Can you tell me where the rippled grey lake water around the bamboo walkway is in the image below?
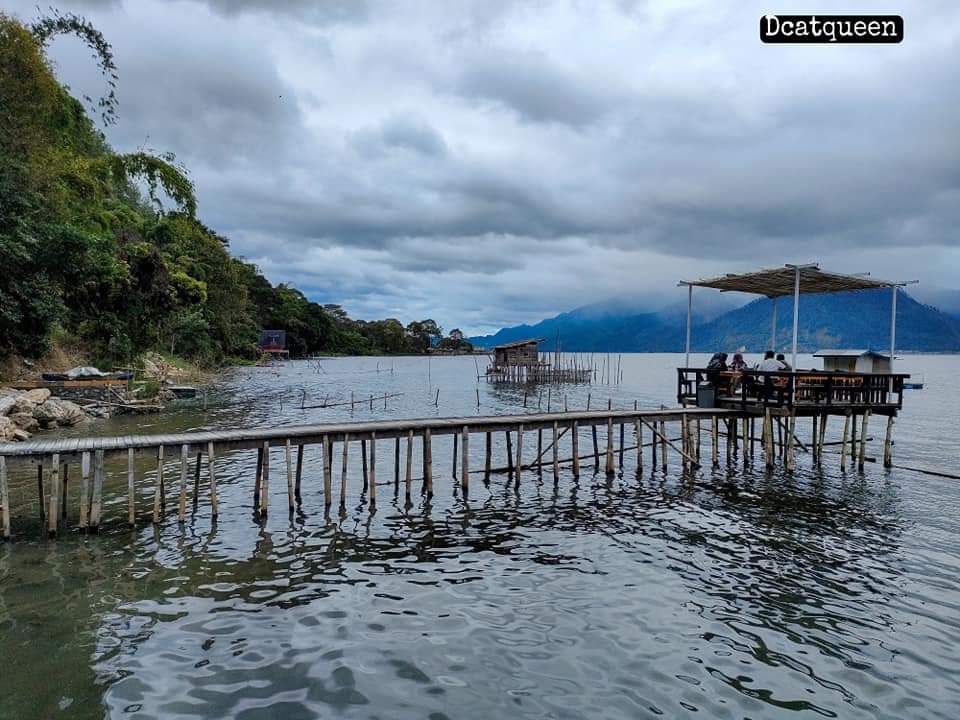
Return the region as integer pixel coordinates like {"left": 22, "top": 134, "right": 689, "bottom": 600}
{"left": 0, "top": 355, "right": 960, "bottom": 720}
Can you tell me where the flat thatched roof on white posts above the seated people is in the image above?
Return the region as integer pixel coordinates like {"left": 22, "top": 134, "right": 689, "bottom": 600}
{"left": 680, "top": 264, "right": 900, "bottom": 298}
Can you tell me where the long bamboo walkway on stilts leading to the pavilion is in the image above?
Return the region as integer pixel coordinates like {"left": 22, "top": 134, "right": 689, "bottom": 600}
{"left": 0, "top": 407, "right": 896, "bottom": 539}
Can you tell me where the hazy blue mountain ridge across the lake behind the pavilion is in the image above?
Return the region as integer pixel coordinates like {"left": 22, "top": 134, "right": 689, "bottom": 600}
{"left": 470, "top": 290, "right": 960, "bottom": 352}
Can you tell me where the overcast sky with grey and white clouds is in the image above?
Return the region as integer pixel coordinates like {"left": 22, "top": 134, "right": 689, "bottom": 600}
{"left": 9, "top": 0, "right": 960, "bottom": 332}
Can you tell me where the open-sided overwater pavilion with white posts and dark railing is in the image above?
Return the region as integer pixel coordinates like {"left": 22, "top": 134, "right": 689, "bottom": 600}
{"left": 677, "top": 263, "right": 914, "bottom": 417}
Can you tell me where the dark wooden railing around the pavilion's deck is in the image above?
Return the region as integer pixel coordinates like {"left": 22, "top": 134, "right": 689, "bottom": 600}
{"left": 677, "top": 368, "right": 910, "bottom": 410}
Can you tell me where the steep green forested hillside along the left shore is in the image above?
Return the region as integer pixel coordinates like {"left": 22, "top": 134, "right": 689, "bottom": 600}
{"left": 0, "top": 13, "right": 440, "bottom": 365}
